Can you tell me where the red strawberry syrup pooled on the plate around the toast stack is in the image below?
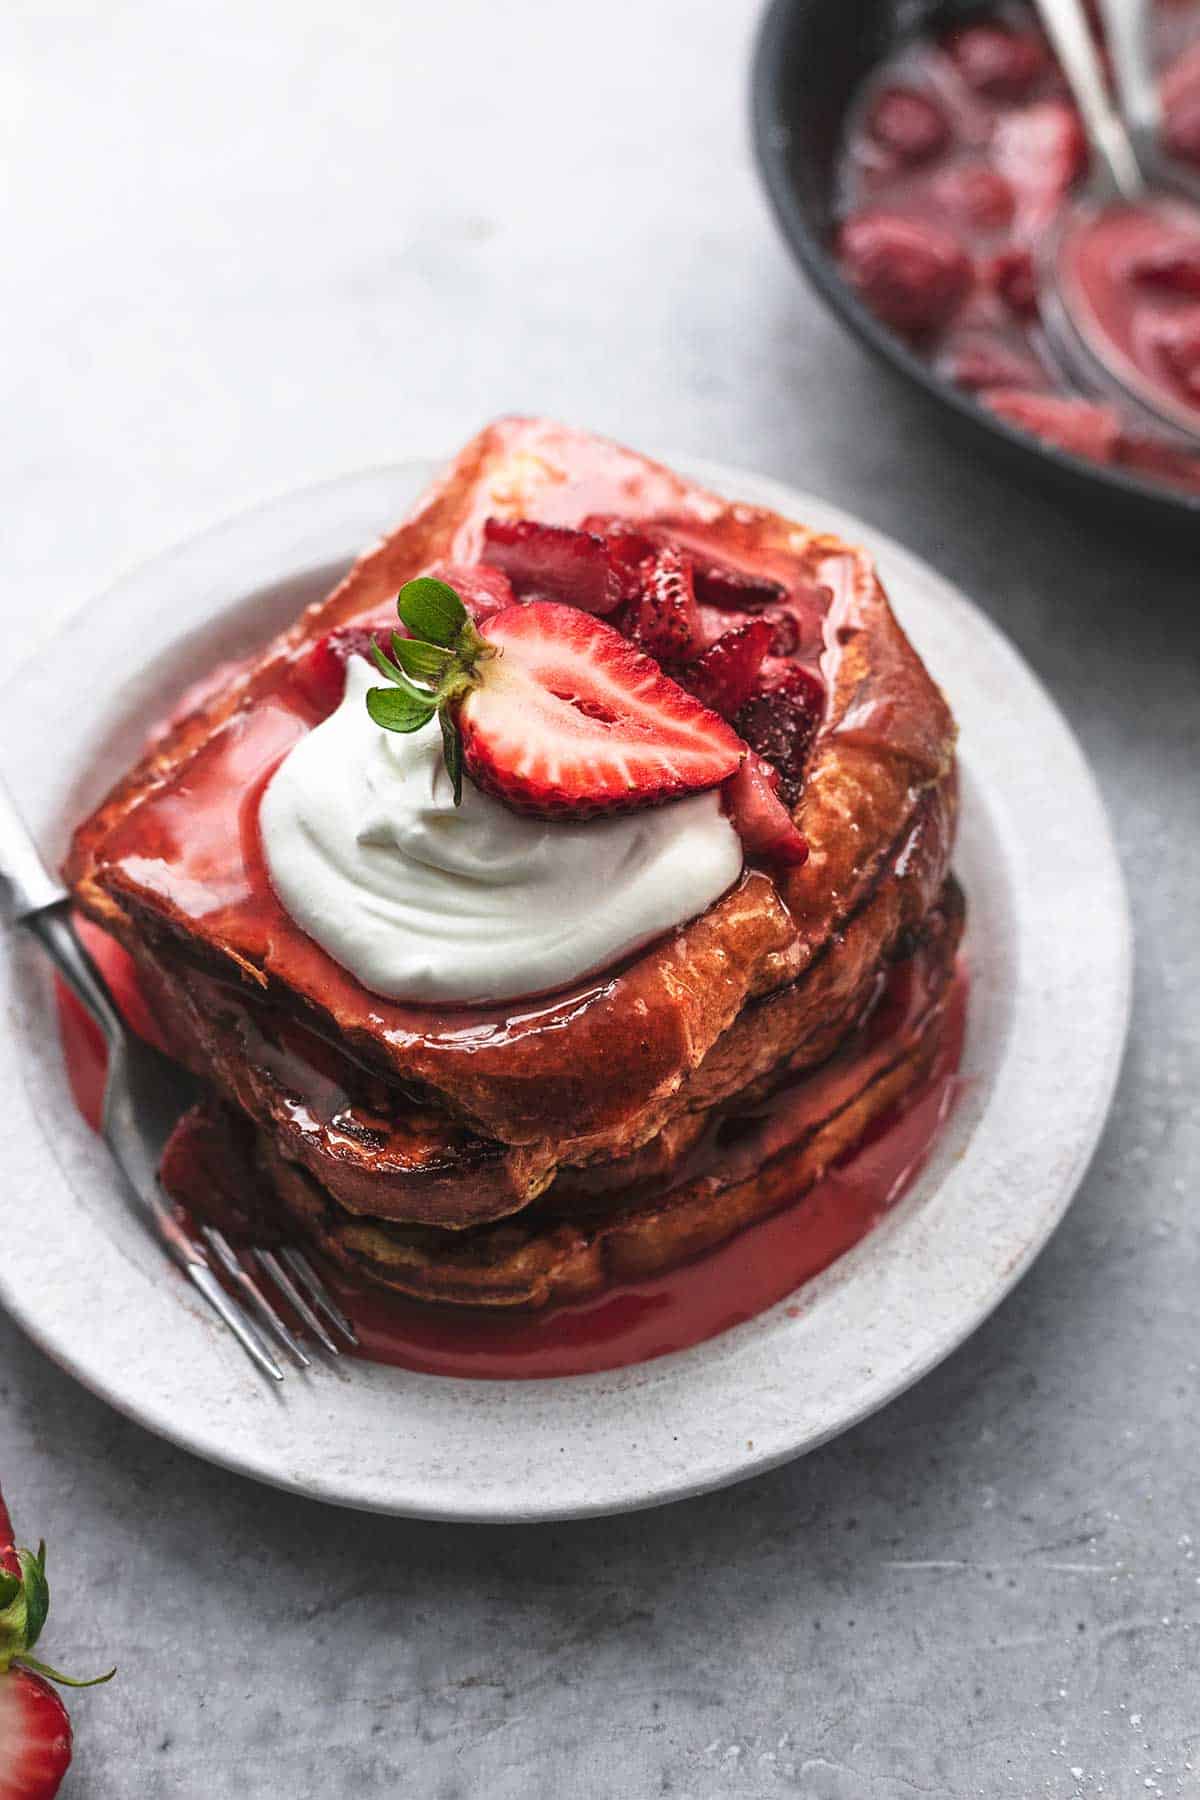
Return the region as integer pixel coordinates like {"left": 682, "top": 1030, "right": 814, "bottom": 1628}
{"left": 58, "top": 920, "right": 966, "bottom": 1381}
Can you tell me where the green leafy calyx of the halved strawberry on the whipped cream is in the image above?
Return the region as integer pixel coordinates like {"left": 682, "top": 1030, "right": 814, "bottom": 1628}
{"left": 367, "top": 574, "right": 497, "bottom": 806}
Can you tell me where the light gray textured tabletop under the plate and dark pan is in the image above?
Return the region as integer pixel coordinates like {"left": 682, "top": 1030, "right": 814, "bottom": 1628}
{"left": 0, "top": 0, "right": 1200, "bottom": 1800}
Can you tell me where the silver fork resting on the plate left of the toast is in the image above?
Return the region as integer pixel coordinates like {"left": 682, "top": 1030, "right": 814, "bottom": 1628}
{"left": 0, "top": 781, "right": 358, "bottom": 1381}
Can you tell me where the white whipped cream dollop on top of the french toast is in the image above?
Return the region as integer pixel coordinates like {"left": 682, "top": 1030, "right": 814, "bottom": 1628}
{"left": 259, "top": 657, "right": 741, "bottom": 1004}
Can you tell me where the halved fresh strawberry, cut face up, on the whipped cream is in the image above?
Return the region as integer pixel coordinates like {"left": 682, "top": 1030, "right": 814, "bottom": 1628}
{"left": 457, "top": 601, "right": 745, "bottom": 819}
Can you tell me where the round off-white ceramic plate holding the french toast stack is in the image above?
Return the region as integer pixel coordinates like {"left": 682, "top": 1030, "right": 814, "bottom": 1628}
{"left": 0, "top": 463, "right": 1130, "bottom": 1519}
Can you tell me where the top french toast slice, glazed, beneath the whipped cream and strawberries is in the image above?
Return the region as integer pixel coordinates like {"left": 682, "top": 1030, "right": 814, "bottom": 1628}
{"left": 67, "top": 419, "right": 955, "bottom": 1159}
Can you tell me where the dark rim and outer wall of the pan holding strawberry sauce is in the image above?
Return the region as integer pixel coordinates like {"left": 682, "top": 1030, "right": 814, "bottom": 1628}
{"left": 752, "top": 0, "right": 1200, "bottom": 531}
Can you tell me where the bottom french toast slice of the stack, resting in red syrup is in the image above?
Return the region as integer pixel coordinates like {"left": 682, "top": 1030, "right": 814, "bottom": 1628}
{"left": 164, "top": 882, "right": 963, "bottom": 1309}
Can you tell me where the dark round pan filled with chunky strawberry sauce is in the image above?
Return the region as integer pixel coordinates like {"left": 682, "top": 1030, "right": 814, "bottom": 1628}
{"left": 754, "top": 0, "right": 1200, "bottom": 527}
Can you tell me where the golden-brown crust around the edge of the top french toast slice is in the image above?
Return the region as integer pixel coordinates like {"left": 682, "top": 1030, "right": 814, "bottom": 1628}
{"left": 67, "top": 419, "right": 954, "bottom": 1159}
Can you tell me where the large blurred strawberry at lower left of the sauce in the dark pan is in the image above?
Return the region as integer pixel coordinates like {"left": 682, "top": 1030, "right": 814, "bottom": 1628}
{"left": 838, "top": 212, "right": 972, "bottom": 337}
